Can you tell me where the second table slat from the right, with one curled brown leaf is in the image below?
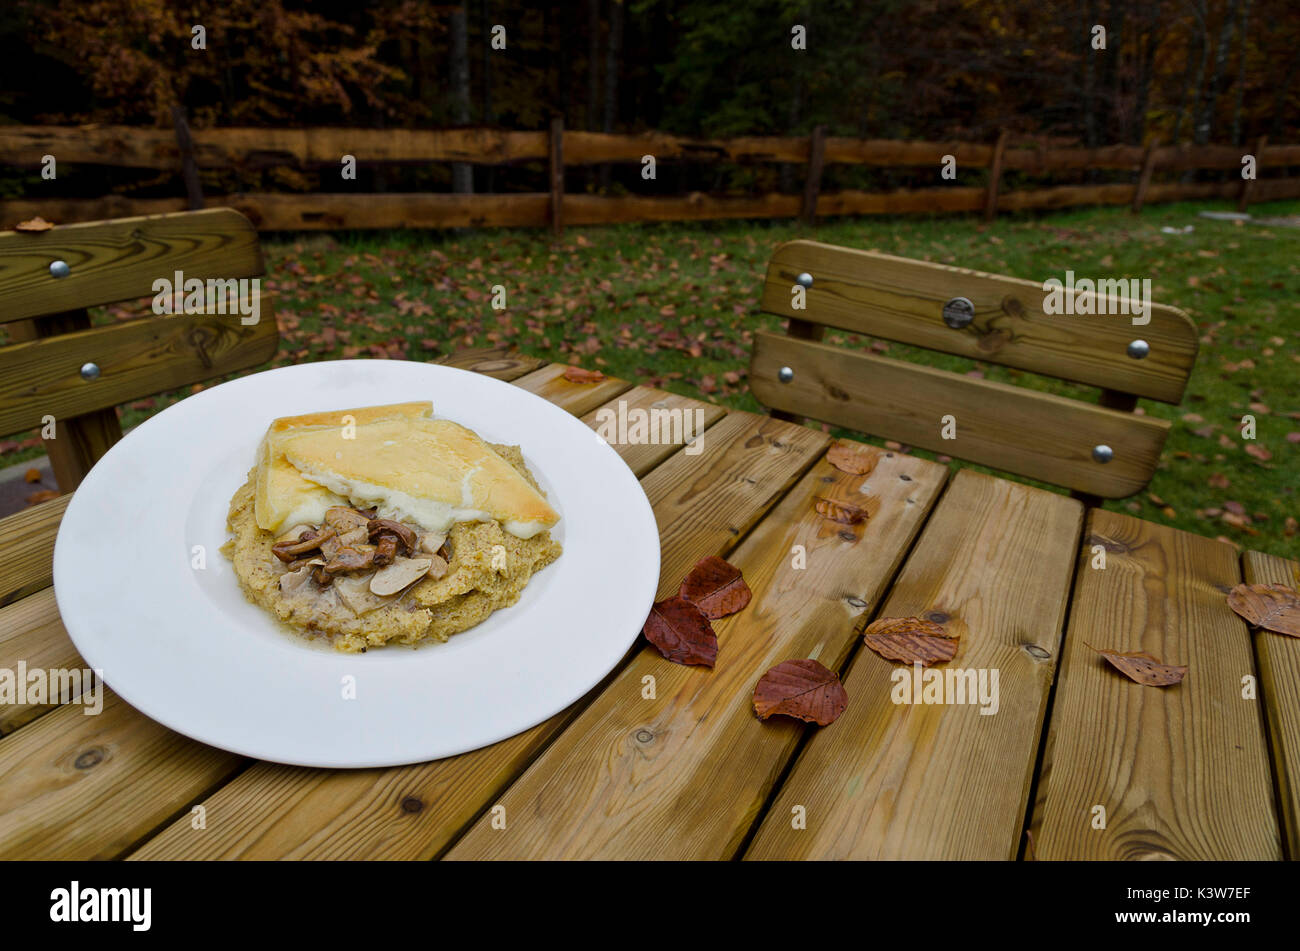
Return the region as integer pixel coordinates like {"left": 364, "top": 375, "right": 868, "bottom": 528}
{"left": 1032, "top": 509, "right": 1282, "bottom": 860}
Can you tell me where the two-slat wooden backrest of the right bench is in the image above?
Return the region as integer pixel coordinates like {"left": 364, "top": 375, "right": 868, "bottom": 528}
{"left": 750, "top": 240, "right": 1197, "bottom": 499}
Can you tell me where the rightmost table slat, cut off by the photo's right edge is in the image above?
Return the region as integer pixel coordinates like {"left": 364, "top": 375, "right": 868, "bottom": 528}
{"left": 1242, "top": 551, "right": 1300, "bottom": 859}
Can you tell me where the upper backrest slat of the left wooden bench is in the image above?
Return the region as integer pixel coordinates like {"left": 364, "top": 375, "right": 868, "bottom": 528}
{"left": 0, "top": 208, "right": 263, "bottom": 323}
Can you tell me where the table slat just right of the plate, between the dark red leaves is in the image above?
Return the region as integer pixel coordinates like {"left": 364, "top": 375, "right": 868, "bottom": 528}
{"left": 447, "top": 447, "right": 948, "bottom": 859}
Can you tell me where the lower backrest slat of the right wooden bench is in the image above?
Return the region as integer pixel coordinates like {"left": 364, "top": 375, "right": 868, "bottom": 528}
{"left": 750, "top": 333, "right": 1170, "bottom": 499}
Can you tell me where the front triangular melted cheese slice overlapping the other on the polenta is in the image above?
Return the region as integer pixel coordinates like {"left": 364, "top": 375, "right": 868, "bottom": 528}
{"left": 277, "top": 417, "right": 559, "bottom": 538}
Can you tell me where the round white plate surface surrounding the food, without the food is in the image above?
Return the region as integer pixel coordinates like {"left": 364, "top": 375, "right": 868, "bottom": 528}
{"left": 55, "top": 360, "right": 659, "bottom": 767}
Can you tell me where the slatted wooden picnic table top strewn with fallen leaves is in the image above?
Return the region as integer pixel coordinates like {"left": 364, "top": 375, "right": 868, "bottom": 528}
{"left": 0, "top": 342, "right": 1300, "bottom": 859}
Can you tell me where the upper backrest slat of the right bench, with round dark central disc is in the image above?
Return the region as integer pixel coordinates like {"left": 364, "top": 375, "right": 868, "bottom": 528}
{"left": 762, "top": 240, "right": 1199, "bottom": 403}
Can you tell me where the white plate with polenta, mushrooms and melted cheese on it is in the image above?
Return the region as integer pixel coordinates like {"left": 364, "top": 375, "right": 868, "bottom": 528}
{"left": 55, "top": 360, "right": 659, "bottom": 767}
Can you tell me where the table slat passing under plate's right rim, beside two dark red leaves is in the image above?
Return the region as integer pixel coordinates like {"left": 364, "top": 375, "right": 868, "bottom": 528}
{"left": 131, "top": 400, "right": 827, "bottom": 859}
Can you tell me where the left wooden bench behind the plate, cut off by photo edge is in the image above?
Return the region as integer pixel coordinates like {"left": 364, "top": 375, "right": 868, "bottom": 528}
{"left": 0, "top": 208, "right": 280, "bottom": 492}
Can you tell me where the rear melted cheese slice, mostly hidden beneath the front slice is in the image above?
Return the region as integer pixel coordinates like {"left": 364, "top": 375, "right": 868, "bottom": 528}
{"left": 254, "top": 400, "right": 433, "bottom": 531}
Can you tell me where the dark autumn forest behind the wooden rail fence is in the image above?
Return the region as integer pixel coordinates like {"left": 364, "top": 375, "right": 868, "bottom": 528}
{"left": 0, "top": 0, "right": 1300, "bottom": 195}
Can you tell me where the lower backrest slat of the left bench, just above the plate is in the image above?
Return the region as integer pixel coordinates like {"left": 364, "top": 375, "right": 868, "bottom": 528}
{"left": 0, "top": 313, "right": 280, "bottom": 434}
